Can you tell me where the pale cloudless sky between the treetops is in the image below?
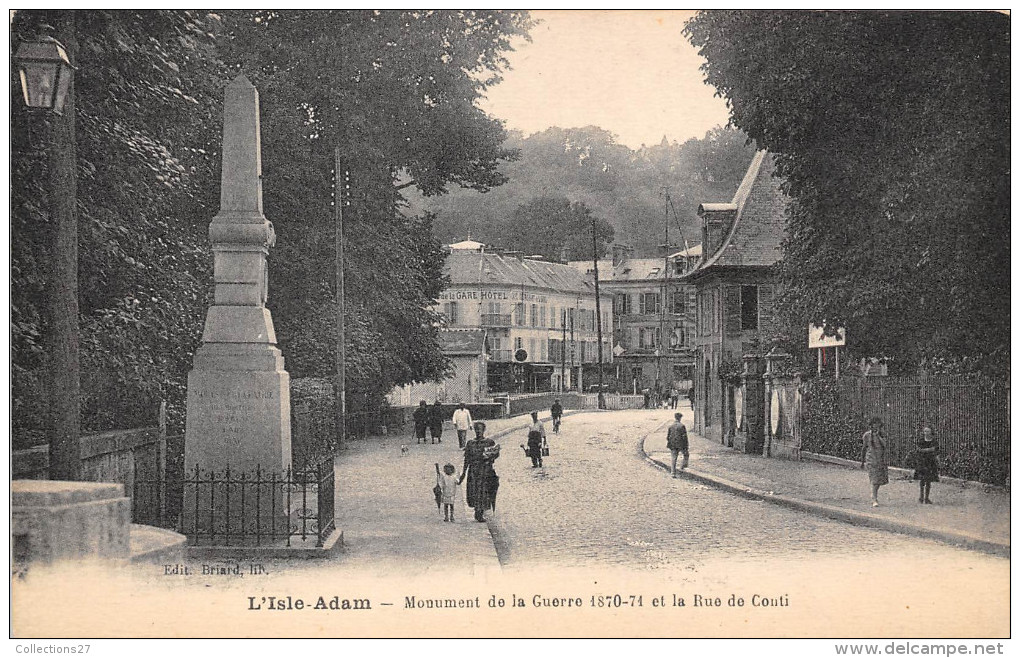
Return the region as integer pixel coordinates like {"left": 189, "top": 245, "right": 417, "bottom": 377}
{"left": 480, "top": 10, "right": 729, "bottom": 148}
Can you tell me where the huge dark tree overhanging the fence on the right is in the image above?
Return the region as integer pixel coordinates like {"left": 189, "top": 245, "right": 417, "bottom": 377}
{"left": 685, "top": 11, "right": 1010, "bottom": 369}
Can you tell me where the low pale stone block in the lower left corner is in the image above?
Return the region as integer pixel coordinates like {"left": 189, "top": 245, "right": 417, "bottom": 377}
{"left": 11, "top": 479, "right": 131, "bottom": 566}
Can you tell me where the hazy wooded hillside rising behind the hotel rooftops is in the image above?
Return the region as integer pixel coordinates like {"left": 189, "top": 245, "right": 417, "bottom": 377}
{"left": 422, "top": 125, "right": 754, "bottom": 256}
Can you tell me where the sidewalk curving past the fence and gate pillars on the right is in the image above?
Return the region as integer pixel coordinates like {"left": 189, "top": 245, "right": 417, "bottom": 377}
{"left": 643, "top": 408, "right": 1010, "bottom": 556}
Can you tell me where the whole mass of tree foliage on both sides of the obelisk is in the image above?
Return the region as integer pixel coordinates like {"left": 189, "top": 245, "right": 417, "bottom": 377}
{"left": 9, "top": 10, "right": 530, "bottom": 435}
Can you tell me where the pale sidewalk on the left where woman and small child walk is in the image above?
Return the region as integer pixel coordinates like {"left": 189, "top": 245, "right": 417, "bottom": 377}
{"left": 336, "top": 412, "right": 569, "bottom": 577}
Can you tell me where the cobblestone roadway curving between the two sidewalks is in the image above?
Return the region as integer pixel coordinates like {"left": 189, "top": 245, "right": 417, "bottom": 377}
{"left": 489, "top": 410, "right": 939, "bottom": 568}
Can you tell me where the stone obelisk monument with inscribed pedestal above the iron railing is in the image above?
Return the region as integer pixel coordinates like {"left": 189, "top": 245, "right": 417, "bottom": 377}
{"left": 185, "top": 75, "right": 291, "bottom": 473}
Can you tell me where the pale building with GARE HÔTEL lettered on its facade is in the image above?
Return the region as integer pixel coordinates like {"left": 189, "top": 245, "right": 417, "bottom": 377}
{"left": 438, "top": 242, "right": 613, "bottom": 396}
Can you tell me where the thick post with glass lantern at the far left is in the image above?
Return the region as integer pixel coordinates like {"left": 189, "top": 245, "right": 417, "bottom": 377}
{"left": 14, "top": 21, "right": 82, "bottom": 480}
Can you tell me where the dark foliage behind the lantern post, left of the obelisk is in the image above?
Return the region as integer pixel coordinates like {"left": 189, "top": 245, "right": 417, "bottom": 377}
{"left": 10, "top": 11, "right": 221, "bottom": 445}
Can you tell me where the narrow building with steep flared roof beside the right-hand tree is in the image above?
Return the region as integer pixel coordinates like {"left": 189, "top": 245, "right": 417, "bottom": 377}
{"left": 683, "top": 151, "right": 786, "bottom": 442}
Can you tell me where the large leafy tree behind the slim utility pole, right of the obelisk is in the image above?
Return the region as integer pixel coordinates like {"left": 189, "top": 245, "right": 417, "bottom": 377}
{"left": 221, "top": 10, "right": 530, "bottom": 411}
